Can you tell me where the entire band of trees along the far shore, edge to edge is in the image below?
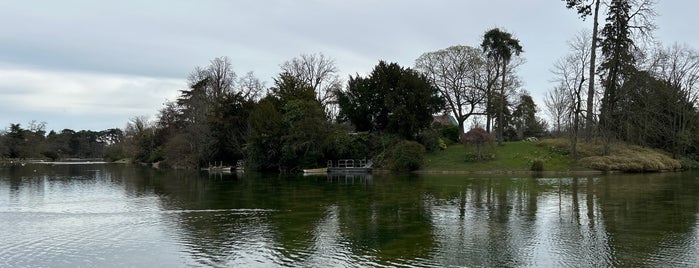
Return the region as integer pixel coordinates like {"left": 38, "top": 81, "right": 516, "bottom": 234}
{"left": 0, "top": 0, "right": 699, "bottom": 172}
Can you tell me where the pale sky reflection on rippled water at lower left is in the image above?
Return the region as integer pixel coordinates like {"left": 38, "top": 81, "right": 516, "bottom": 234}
{"left": 0, "top": 164, "right": 187, "bottom": 267}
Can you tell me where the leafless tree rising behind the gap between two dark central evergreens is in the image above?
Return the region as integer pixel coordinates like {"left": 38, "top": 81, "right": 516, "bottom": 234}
{"left": 281, "top": 53, "right": 342, "bottom": 117}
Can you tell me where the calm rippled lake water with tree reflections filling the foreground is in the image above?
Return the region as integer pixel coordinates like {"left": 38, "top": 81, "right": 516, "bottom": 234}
{"left": 0, "top": 164, "right": 699, "bottom": 267}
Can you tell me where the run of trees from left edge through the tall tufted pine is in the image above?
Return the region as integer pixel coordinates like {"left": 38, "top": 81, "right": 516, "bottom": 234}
{"left": 0, "top": 29, "right": 545, "bottom": 171}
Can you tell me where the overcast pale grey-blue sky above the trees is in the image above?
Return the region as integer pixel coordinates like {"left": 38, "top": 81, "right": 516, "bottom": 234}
{"left": 0, "top": 0, "right": 699, "bottom": 130}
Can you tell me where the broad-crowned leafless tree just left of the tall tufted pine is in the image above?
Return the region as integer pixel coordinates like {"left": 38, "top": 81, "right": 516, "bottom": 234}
{"left": 415, "top": 46, "right": 486, "bottom": 135}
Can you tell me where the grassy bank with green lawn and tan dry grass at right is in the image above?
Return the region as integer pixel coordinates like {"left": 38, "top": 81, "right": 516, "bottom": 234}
{"left": 422, "top": 139, "right": 681, "bottom": 173}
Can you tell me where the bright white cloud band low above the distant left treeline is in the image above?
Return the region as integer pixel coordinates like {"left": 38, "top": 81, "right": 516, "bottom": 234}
{"left": 0, "top": 67, "right": 186, "bottom": 130}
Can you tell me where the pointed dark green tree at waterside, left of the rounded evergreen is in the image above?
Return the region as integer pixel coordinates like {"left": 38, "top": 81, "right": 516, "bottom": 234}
{"left": 246, "top": 73, "right": 334, "bottom": 171}
